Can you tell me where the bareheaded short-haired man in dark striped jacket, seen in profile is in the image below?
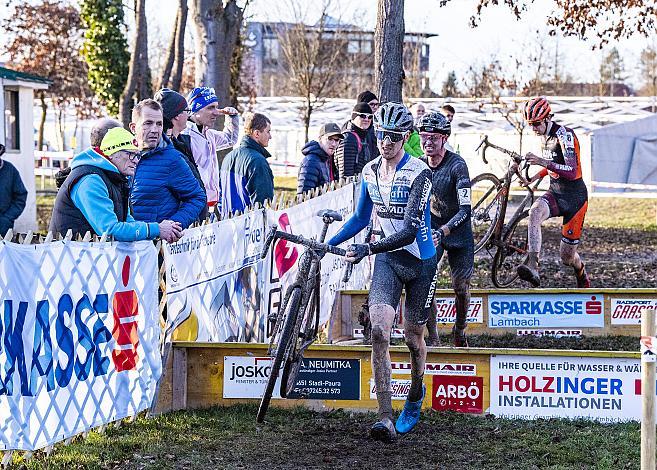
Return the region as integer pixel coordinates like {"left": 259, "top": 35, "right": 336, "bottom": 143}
{"left": 221, "top": 113, "right": 274, "bottom": 217}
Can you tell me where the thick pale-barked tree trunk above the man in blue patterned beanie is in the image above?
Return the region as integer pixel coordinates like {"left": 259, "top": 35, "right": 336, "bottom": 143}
{"left": 192, "top": 0, "right": 244, "bottom": 106}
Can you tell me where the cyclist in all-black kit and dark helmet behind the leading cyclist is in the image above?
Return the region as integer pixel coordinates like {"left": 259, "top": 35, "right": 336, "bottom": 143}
{"left": 418, "top": 112, "right": 474, "bottom": 347}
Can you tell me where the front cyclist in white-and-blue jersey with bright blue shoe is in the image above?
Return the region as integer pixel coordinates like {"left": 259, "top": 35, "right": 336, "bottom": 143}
{"left": 328, "top": 103, "right": 436, "bottom": 442}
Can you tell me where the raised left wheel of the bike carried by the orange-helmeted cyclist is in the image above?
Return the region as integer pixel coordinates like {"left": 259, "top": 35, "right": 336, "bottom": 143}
{"left": 470, "top": 173, "right": 502, "bottom": 253}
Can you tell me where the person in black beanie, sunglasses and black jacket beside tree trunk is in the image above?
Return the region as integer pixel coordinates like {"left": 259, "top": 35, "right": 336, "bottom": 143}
{"left": 332, "top": 103, "right": 373, "bottom": 180}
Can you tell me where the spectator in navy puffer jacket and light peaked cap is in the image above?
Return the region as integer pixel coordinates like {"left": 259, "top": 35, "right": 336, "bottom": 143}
{"left": 297, "top": 122, "right": 344, "bottom": 194}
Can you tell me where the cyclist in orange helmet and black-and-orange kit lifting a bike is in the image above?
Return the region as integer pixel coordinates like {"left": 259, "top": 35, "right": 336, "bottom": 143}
{"left": 517, "top": 96, "right": 591, "bottom": 287}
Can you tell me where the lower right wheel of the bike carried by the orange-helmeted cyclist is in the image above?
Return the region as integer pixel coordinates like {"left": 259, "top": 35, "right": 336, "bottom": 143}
{"left": 492, "top": 211, "right": 529, "bottom": 287}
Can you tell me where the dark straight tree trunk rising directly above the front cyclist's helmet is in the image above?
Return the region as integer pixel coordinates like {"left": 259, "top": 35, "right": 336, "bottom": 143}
{"left": 374, "top": 0, "right": 404, "bottom": 103}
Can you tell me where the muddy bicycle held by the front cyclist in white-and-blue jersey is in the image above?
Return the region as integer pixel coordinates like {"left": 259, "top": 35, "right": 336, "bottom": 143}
{"left": 256, "top": 210, "right": 353, "bottom": 423}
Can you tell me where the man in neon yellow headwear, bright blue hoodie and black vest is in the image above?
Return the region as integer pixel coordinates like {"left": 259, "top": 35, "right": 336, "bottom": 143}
{"left": 49, "top": 127, "right": 182, "bottom": 242}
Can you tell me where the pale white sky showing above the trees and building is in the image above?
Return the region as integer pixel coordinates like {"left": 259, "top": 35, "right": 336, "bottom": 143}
{"left": 0, "top": 0, "right": 648, "bottom": 91}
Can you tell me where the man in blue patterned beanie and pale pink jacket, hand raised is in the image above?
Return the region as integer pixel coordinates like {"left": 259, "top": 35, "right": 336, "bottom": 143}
{"left": 182, "top": 87, "right": 239, "bottom": 207}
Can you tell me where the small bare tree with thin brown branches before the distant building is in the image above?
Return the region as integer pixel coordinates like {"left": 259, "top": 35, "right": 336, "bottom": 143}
{"left": 278, "top": 2, "right": 348, "bottom": 141}
